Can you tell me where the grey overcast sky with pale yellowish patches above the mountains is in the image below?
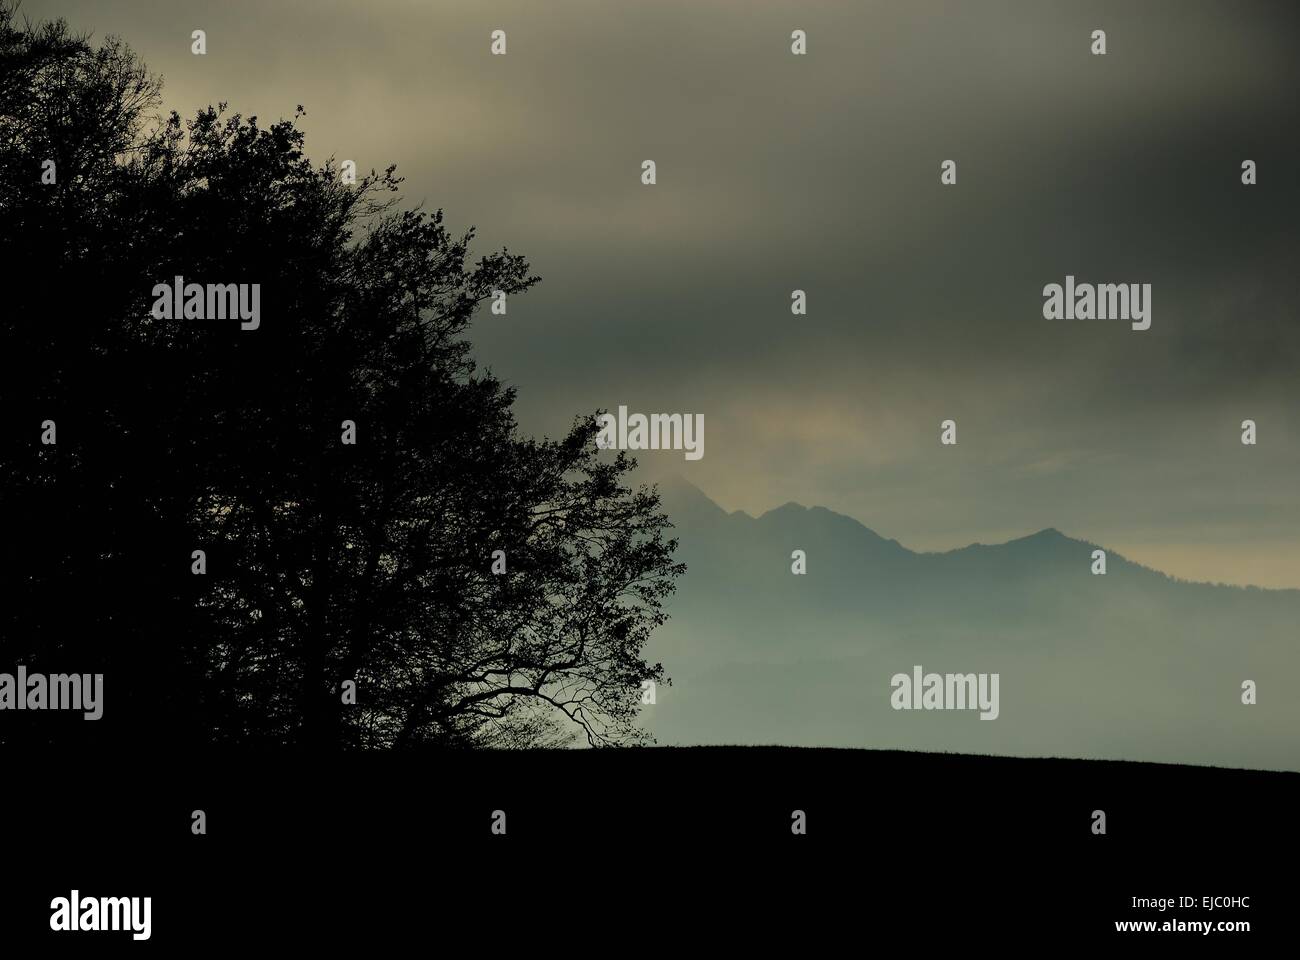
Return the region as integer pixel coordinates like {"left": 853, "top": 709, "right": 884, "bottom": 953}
{"left": 32, "top": 0, "right": 1300, "bottom": 587}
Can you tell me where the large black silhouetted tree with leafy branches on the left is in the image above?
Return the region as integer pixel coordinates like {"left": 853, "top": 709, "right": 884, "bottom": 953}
{"left": 0, "top": 9, "right": 683, "bottom": 749}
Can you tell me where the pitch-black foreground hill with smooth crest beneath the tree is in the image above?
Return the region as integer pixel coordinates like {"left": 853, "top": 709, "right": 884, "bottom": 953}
{"left": 0, "top": 747, "right": 1300, "bottom": 947}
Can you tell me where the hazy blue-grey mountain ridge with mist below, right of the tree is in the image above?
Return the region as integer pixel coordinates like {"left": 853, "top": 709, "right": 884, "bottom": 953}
{"left": 645, "top": 479, "right": 1300, "bottom": 770}
